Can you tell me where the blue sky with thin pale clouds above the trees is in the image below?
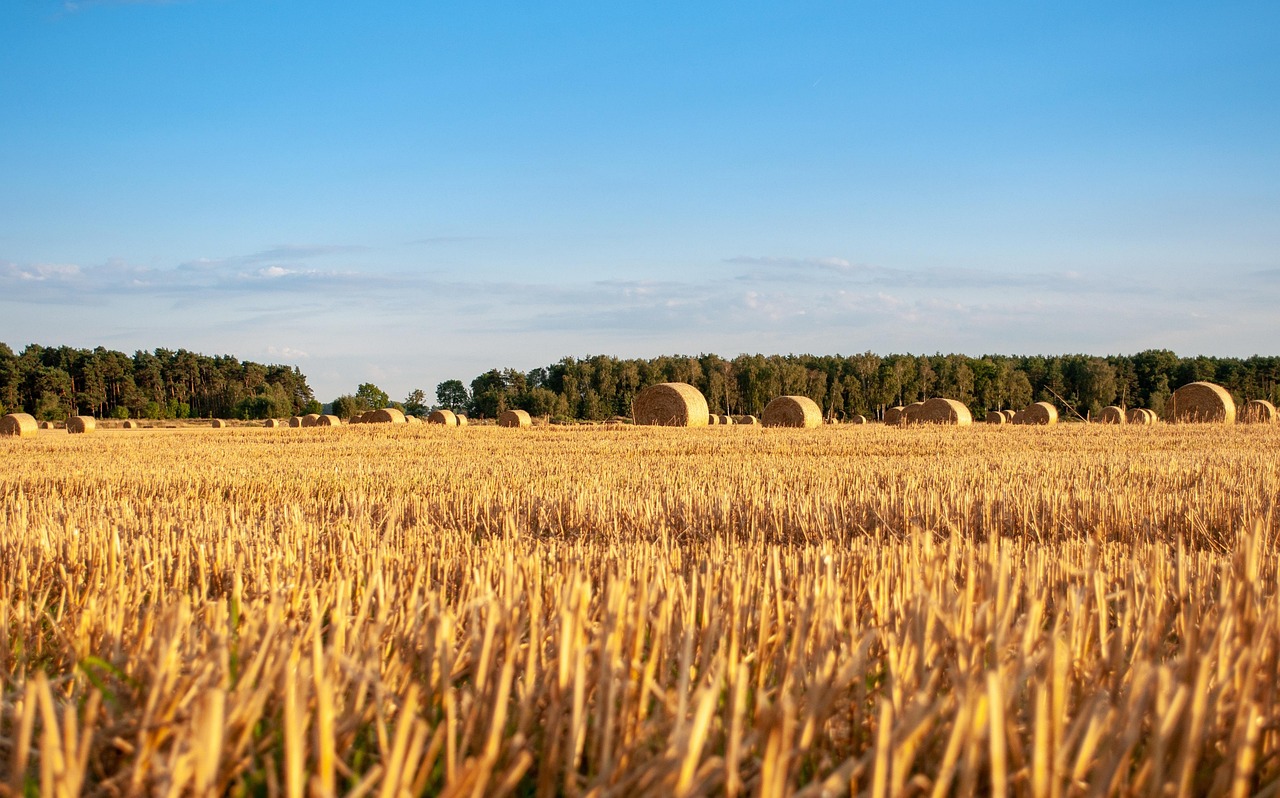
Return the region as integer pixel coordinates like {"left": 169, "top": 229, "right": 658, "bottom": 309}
{"left": 0, "top": 0, "right": 1280, "bottom": 400}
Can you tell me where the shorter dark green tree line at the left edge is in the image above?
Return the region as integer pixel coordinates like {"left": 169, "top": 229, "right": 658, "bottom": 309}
{"left": 0, "top": 343, "right": 320, "bottom": 420}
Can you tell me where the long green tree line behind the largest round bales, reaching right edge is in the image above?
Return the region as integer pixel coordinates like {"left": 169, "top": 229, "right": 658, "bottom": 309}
{"left": 436, "top": 350, "right": 1280, "bottom": 420}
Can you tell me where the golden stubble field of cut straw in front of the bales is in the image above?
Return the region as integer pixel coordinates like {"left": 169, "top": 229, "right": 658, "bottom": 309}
{"left": 0, "top": 425, "right": 1280, "bottom": 797}
